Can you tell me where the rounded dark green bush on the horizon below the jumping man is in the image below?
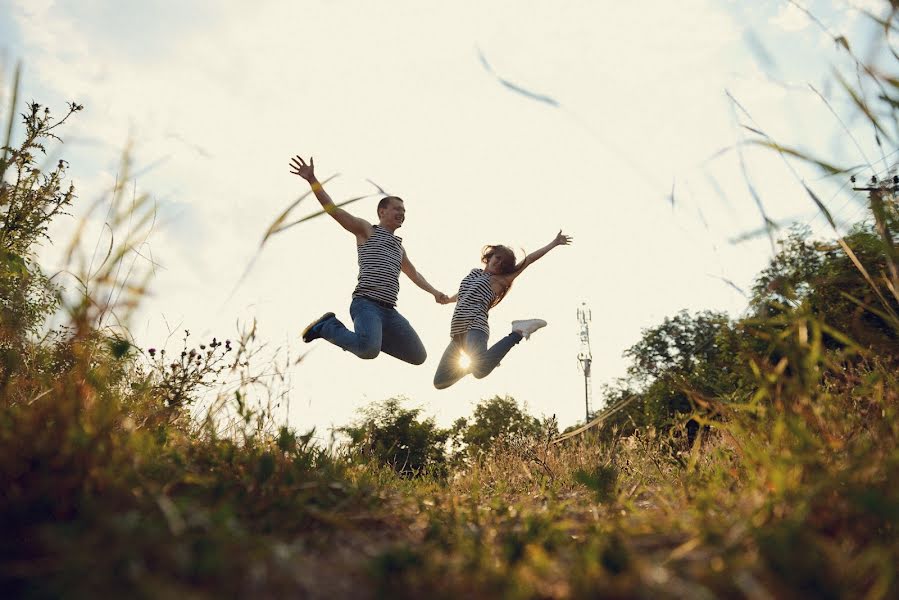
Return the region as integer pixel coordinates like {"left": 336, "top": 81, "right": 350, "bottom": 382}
{"left": 339, "top": 398, "right": 449, "bottom": 477}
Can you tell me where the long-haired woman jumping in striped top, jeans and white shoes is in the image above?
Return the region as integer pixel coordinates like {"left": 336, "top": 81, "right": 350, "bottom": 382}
{"left": 434, "top": 231, "right": 572, "bottom": 390}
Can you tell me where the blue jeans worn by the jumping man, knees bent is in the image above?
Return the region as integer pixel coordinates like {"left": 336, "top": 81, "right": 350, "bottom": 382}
{"left": 319, "top": 298, "right": 428, "bottom": 365}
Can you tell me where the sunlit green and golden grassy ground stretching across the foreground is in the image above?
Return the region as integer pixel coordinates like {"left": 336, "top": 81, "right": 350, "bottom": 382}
{"left": 0, "top": 318, "right": 899, "bottom": 598}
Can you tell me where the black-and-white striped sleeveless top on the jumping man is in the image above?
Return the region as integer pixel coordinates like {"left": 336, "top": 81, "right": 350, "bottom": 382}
{"left": 353, "top": 225, "right": 403, "bottom": 306}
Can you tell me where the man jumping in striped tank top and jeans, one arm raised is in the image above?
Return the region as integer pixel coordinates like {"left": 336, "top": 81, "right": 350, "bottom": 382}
{"left": 290, "top": 156, "right": 449, "bottom": 365}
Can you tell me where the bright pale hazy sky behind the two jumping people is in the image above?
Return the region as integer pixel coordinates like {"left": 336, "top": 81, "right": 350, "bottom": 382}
{"left": 0, "top": 0, "right": 889, "bottom": 430}
